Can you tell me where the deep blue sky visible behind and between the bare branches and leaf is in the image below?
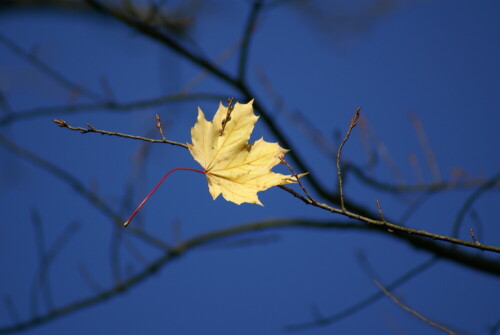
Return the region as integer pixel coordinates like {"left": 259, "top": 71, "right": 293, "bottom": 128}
{"left": 0, "top": 0, "right": 500, "bottom": 334}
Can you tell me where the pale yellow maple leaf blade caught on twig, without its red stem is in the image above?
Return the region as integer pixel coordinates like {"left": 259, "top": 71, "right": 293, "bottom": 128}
{"left": 188, "top": 100, "right": 302, "bottom": 205}
